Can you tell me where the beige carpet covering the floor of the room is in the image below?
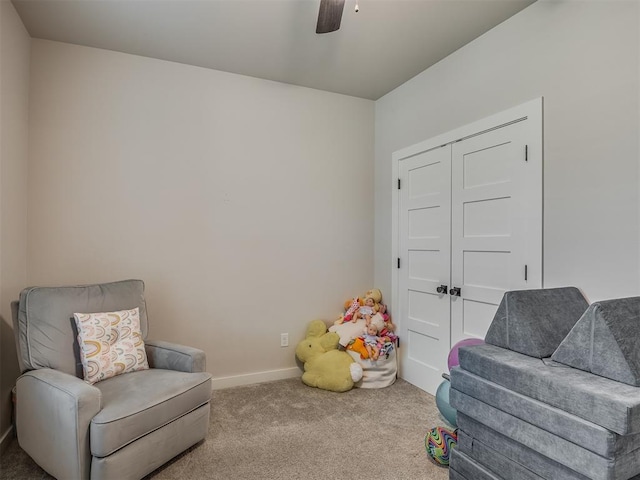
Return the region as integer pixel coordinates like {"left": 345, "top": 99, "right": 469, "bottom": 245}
{"left": 0, "top": 379, "right": 448, "bottom": 480}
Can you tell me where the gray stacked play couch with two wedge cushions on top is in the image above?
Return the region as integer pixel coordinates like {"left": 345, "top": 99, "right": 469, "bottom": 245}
{"left": 449, "top": 287, "right": 640, "bottom": 480}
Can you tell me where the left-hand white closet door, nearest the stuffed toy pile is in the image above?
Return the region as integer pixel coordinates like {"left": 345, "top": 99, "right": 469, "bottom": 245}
{"left": 399, "top": 145, "right": 451, "bottom": 392}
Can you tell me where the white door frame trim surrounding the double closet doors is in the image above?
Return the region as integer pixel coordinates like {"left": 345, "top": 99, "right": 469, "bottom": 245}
{"left": 391, "top": 97, "right": 543, "bottom": 390}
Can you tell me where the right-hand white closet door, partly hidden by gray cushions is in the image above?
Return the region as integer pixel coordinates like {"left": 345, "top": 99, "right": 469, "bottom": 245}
{"left": 451, "top": 120, "right": 542, "bottom": 345}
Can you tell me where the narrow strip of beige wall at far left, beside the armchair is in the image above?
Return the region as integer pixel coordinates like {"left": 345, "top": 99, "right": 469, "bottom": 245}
{"left": 0, "top": 1, "right": 31, "bottom": 450}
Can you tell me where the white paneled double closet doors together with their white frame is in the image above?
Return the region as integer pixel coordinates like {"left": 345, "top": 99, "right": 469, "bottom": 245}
{"left": 393, "top": 99, "right": 542, "bottom": 394}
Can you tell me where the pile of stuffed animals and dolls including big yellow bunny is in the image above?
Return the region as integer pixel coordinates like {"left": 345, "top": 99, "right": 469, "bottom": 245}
{"left": 296, "top": 288, "right": 397, "bottom": 392}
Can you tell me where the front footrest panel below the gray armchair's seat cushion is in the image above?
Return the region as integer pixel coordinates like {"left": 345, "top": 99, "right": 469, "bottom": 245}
{"left": 91, "top": 404, "right": 210, "bottom": 480}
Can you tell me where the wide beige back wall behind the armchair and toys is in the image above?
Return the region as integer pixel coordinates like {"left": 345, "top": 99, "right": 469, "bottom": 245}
{"left": 28, "top": 40, "right": 374, "bottom": 385}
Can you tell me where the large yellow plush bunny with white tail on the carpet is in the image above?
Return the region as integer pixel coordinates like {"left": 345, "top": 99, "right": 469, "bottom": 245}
{"left": 296, "top": 320, "right": 362, "bottom": 392}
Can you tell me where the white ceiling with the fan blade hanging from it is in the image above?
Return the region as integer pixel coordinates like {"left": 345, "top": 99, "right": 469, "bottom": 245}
{"left": 12, "top": 0, "right": 535, "bottom": 100}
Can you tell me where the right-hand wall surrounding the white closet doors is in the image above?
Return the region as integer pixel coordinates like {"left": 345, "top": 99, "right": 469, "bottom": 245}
{"left": 374, "top": 0, "right": 640, "bottom": 301}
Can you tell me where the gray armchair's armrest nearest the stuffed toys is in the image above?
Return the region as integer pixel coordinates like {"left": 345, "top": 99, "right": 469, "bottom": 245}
{"left": 144, "top": 340, "right": 207, "bottom": 373}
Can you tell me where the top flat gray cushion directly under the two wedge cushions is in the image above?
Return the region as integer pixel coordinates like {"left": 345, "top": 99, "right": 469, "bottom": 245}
{"left": 458, "top": 345, "right": 640, "bottom": 435}
